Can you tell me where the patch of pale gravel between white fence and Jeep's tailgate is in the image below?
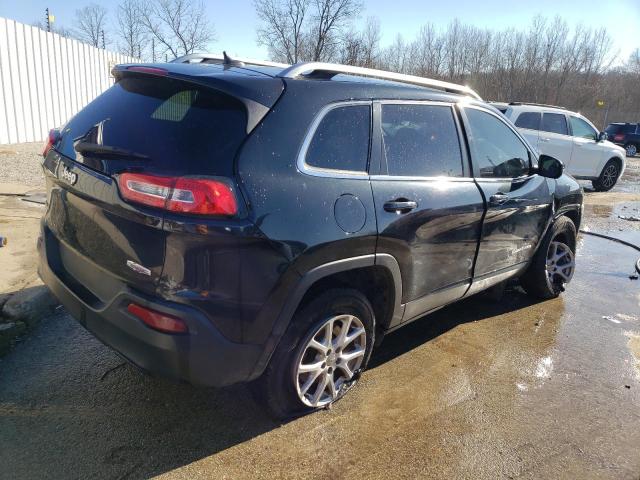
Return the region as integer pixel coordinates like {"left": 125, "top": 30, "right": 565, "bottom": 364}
{"left": 0, "top": 142, "right": 44, "bottom": 189}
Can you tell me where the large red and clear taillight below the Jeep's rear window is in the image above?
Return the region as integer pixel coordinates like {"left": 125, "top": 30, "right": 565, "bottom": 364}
{"left": 118, "top": 173, "right": 238, "bottom": 216}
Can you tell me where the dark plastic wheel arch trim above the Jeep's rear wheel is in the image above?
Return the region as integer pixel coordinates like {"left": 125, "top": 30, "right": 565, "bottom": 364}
{"left": 249, "top": 254, "right": 403, "bottom": 380}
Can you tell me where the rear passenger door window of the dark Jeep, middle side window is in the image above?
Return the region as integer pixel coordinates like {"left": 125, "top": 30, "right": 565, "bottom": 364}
{"left": 382, "top": 104, "right": 462, "bottom": 177}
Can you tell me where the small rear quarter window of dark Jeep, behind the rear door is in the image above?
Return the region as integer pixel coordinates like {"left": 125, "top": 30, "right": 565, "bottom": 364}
{"left": 305, "top": 105, "right": 371, "bottom": 172}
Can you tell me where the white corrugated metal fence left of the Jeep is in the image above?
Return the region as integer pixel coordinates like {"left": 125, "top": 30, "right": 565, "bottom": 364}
{"left": 0, "top": 17, "right": 139, "bottom": 145}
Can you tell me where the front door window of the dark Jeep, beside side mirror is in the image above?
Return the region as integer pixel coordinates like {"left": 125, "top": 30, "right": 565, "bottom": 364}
{"left": 465, "top": 108, "right": 530, "bottom": 178}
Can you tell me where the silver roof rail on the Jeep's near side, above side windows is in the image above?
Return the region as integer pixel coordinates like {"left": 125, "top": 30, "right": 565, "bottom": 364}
{"left": 278, "top": 62, "right": 482, "bottom": 100}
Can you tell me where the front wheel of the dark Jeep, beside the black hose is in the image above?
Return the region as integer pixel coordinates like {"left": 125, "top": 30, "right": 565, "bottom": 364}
{"left": 520, "top": 217, "right": 576, "bottom": 300}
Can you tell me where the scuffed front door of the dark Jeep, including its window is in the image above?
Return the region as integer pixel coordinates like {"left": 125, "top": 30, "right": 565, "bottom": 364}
{"left": 463, "top": 106, "right": 551, "bottom": 289}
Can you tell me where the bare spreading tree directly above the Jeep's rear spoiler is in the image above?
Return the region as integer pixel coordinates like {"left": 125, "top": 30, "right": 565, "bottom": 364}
{"left": 140, "top": 0, "right": 215, "bottom": 58}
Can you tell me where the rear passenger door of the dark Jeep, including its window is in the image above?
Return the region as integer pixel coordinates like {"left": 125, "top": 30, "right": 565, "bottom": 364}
{"left": 371, "top": 101, "right": 484, "bottom": 326}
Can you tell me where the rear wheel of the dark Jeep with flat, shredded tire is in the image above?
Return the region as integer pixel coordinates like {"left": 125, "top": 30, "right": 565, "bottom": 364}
{"left": 253, "top": 289, "right": 375, "bottom": 419}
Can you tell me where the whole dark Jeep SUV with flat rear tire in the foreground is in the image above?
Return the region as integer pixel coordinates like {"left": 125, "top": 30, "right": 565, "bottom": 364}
{"left": 38, "top": 56, "right": 582, "bottom": 416}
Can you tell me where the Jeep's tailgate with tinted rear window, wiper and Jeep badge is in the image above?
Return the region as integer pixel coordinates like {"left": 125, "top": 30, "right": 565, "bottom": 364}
{"left": 40, "top": 75, "right": 252, "bottom": 301}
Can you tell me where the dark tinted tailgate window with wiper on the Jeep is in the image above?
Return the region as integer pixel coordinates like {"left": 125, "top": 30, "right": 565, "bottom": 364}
{"left": 58, "top": 77, "right": 247, "bottom": 175}
